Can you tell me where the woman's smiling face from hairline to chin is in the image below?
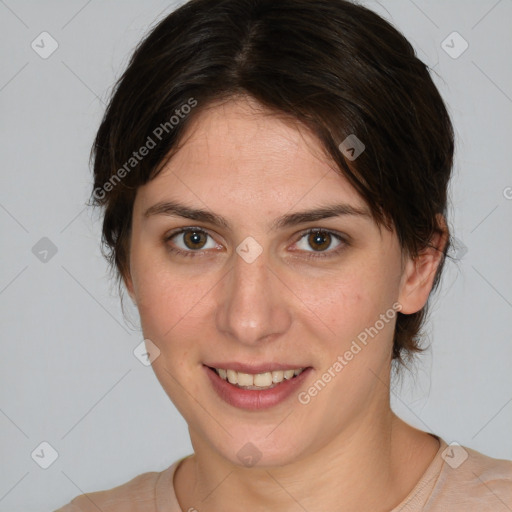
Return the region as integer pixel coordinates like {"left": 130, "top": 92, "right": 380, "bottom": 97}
{"left": 127, "top": 96, "right": 426, "bottom": 465}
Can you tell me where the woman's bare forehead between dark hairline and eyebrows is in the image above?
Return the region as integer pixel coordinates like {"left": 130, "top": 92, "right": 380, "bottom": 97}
{"left": 138, "top": 98, "right": 364, "bottom": 206}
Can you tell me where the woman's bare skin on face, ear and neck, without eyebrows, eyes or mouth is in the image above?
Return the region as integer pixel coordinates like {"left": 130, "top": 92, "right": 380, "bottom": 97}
{"left": 125, "top": 98, "right": 446, "bottom": 512}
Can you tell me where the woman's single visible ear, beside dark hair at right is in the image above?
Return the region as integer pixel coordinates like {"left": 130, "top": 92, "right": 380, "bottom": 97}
{"left": 398, "top": 214, "right": 449, "bottom": 315}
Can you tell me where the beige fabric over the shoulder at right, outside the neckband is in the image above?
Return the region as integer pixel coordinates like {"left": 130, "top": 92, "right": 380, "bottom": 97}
{"left": 431, "top": 445, "right": 512, "bottom": 512}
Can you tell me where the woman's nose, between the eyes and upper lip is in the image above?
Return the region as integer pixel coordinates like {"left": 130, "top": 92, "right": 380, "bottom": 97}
{"left": 216, "top": 243, "right": 292, "bottom": 345}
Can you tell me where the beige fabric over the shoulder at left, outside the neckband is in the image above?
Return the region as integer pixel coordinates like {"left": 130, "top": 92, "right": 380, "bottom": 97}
{"left": 55, "top": 468, "right": 170, "bottom": 512}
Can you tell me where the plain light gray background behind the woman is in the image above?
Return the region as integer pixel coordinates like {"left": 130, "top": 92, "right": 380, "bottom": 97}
{"left": 0, "top": 0, "right": 512, "bottom": 512}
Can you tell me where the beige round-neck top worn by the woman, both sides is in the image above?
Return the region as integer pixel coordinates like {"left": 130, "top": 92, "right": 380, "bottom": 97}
{"left": 55, "top": 436, "right": 512, "bottom": 512}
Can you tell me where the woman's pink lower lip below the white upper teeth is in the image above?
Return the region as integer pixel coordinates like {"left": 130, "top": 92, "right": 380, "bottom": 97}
{"left": 203, "top": 366, "right": 312, "bottom": 411}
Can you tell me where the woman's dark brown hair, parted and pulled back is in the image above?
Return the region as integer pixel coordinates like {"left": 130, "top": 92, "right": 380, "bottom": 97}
{"left": 91, "top": 0, "right": 454, "bottom": 363}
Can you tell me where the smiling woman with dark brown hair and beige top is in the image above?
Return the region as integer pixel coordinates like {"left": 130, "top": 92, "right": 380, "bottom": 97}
{"left": 54, "top": 0, "right": 512, "bottom": 512}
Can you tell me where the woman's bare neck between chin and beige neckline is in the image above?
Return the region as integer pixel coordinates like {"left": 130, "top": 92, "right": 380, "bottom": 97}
{"left": 175, "top": 405, "right": 438, "bottom": 512}
